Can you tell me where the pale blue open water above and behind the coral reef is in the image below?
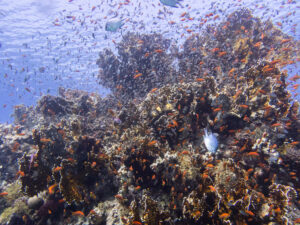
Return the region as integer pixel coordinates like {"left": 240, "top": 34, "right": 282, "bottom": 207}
{"left": 0, "top": 0, "right": 300, "bottom": 123}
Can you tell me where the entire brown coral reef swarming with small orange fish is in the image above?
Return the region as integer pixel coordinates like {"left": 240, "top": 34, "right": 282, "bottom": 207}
{"left": 0, "top": 9, "right": 300, "bottom": 225}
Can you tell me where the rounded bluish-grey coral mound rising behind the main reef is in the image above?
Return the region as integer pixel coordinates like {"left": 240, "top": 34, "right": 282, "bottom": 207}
{"left": 97, "top": 33, "right": 176, "bottom": 99}
